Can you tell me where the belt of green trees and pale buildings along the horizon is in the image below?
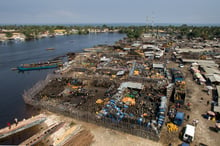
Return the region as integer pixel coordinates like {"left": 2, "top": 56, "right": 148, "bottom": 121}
{"left": 0, "top": 24, "right": 220, "bottom": 40}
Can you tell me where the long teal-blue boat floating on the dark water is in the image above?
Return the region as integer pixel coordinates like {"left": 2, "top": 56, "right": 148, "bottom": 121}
{"left": 17, "top": 61, "right": 62, "bottom": 71}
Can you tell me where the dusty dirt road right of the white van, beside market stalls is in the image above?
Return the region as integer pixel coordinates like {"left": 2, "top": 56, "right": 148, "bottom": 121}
{"left": 184, "top": 65, "right": 220, "bottom": 146}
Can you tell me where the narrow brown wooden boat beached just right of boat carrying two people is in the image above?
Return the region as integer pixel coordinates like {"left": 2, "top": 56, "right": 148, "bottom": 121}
{"left": 19, "top": 122, "right": 64, "bottom": 146}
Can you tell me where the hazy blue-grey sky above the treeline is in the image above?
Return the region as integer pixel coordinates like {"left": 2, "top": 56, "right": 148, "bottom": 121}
{"left": 0, "top": 0, "right": 220, "bottom": 24}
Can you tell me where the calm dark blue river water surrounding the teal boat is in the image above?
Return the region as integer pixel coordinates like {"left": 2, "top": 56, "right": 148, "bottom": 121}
{"left": 0, "top": 33, "right": 125, "bottom": 127}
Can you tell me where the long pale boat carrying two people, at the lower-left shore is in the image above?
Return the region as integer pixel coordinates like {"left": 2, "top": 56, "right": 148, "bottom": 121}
{"left": 0, "top": 114, "right": 47, "bottom": 139}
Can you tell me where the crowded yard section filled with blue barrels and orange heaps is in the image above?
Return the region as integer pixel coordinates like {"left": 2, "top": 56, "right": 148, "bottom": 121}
{"left": 96, "top": 82, "right": 167, "bottom": 132}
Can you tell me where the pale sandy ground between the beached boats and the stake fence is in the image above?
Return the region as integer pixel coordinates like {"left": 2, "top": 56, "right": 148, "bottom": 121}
{"left": 41, "top": 112, "right": 162, "bottom": 146}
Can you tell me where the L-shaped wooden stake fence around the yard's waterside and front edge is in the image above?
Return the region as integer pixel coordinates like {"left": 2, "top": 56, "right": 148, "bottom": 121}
{"left": 23, "top": 75, "right": 160, "bottom": 141}
